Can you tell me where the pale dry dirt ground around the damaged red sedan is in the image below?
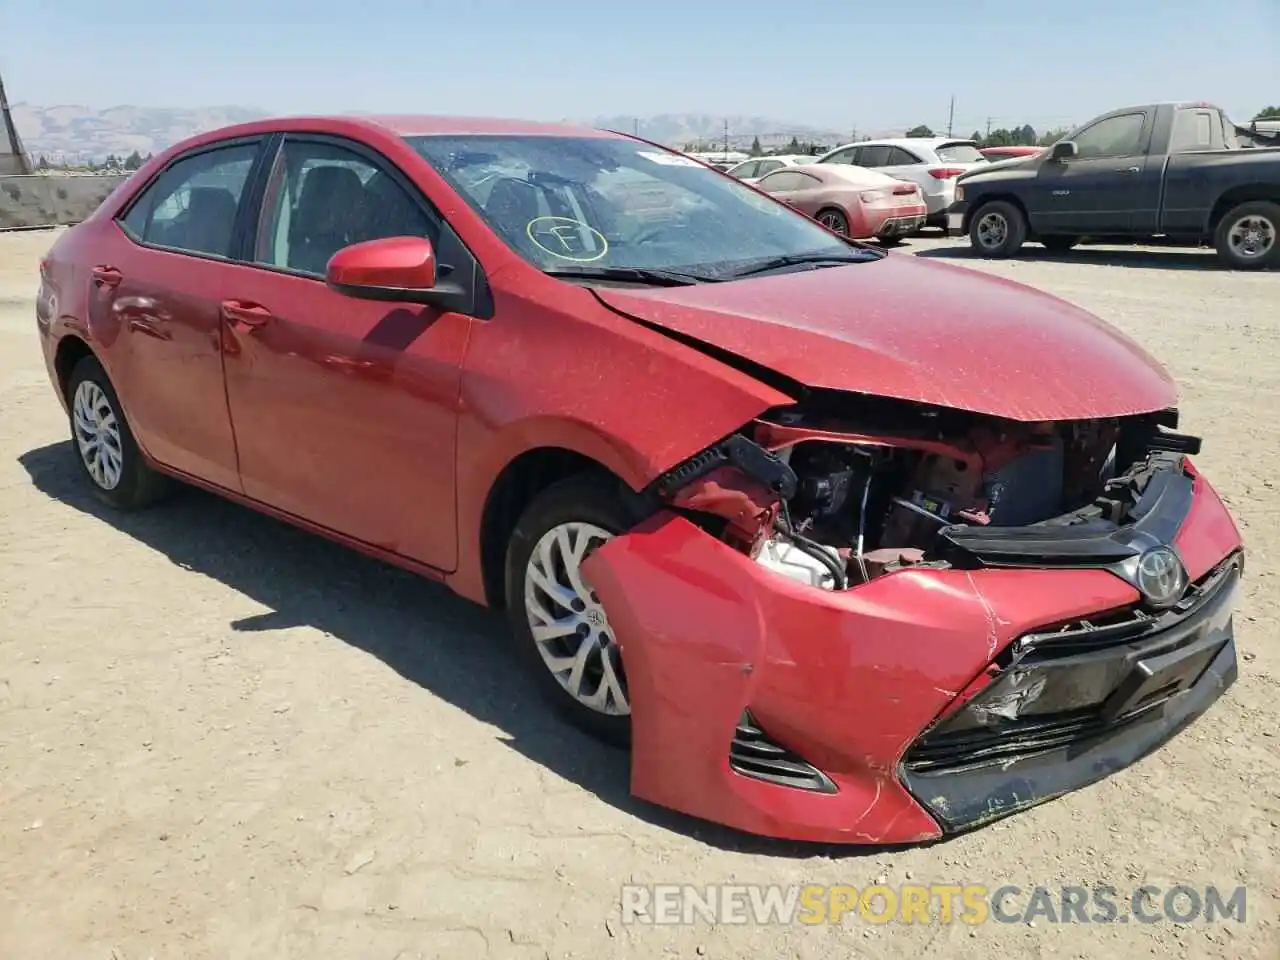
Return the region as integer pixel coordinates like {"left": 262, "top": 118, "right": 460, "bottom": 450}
{"left": 0, "top": 233, "right": 1280, "bottom": 960}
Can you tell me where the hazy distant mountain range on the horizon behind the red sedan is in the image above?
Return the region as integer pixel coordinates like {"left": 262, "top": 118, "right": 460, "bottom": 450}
{"left": 13, "top": 102, "right": 849, "bottom": 164}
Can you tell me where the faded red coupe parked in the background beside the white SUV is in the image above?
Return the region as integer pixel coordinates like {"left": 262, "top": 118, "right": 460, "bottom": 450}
{"left": 755, "top": 164, "right": 929, "bottom": 247}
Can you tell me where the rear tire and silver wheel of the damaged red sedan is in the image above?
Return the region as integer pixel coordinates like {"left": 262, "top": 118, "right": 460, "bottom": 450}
{"left": 67, "top": 357, "right": 169, "bottom": 509}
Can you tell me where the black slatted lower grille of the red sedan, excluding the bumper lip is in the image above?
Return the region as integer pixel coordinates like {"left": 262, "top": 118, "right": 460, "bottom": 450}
{"left": 902, "top": 557, "right": 1240, "bottom": 772}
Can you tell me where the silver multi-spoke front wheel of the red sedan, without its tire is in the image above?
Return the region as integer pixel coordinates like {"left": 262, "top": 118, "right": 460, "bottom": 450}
{"left": 525, "top": 521, "right": 631, "bottom": 717}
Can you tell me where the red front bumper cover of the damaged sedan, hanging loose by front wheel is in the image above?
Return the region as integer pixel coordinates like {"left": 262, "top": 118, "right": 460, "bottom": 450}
{"left": 584, "top": 512, "right": 1135, "bottom": 844}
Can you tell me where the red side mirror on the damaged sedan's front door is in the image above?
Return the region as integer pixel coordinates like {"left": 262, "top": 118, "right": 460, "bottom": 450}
{"left": 325, "top": 237, "right": 467, "bottom": 310}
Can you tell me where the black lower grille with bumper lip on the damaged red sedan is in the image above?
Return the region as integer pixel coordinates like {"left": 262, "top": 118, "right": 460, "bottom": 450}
{"left": 899, "top": 553, "right": 1243, "bottom": 833}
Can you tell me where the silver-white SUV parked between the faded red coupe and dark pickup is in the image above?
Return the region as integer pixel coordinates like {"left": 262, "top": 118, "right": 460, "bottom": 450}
{"left": 818, "top": 137, "right": 988, "bottom": 230}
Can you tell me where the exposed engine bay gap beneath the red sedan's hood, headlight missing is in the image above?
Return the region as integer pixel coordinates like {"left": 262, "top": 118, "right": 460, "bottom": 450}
{"left": 653, "top": 398, "right": 1199, "bottom": 590}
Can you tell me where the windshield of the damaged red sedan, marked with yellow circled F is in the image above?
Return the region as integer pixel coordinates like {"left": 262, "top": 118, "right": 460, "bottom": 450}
{"left": 408, "top": 136, "right": 863, "bottom": 278}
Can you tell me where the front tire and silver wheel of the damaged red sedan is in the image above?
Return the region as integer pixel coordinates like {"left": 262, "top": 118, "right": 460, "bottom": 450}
{"left": 506, "top": 474, "right": 639, "bottom": 746}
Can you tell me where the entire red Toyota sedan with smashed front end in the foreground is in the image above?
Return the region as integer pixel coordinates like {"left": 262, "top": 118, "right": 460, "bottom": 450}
{"left": 37, "top": 118, "right": 1243, "bottom": 842}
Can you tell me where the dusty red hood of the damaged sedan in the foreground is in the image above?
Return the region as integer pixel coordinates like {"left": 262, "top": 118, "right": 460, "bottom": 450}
{"left": 595, "top": 253, "right": 1176, "bottom": 421}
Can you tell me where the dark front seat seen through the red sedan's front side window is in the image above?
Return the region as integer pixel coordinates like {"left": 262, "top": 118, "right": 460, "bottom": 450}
{"left": 288, "top": 166, "right": 365, "bottom": 274}
